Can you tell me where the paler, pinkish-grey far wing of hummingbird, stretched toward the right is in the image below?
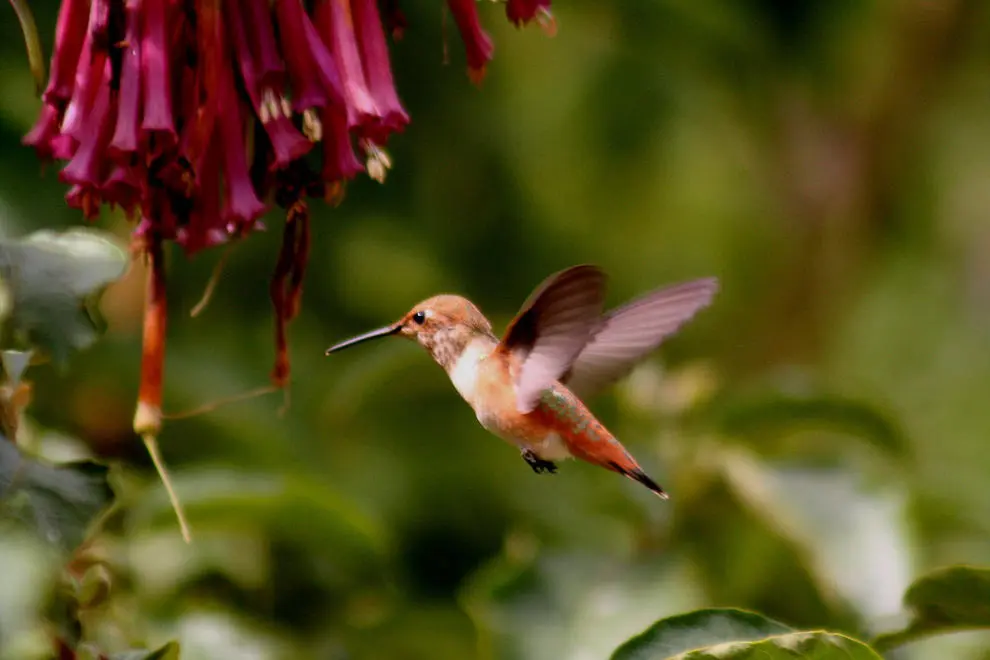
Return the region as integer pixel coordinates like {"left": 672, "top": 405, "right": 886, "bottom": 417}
{"left": 561, "top": 278, "right": 718, "bottom": 397}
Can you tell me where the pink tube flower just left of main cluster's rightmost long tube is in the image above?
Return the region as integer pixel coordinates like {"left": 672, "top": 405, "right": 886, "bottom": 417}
{"left": 314, "top": 0, "right": 381, "bottom": 128}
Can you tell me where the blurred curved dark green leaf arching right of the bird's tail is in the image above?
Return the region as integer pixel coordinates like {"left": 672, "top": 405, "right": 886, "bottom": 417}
{"left": 717, "top": 392, "right": 908, "bottom": 456}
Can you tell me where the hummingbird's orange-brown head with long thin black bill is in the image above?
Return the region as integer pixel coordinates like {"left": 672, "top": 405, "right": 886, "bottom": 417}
{"left": 326, "top": 294, "right": 492, "bottom": 368}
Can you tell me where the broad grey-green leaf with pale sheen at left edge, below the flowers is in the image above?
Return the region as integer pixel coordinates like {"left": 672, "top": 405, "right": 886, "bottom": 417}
{"left": 0, "top": 229, "right": 128, "bottom": 364}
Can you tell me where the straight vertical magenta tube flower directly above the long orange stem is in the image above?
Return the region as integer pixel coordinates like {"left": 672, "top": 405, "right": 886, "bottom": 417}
{"left": 140, "top": 0, "right": 175, "bottom": 142}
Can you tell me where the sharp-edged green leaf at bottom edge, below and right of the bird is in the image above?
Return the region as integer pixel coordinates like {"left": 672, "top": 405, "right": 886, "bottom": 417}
{"left": 612, "top": 609, "right": 880, "bottom": 660}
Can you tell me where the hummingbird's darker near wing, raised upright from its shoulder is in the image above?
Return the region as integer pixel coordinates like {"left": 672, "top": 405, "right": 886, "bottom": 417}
{"left": 498, "top": 265, "right": 605, "bottom": 413}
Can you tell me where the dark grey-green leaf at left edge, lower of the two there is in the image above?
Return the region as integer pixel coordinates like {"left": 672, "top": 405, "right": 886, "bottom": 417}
{"left": 0, "top": 436, "right": 113, "bottom": 553}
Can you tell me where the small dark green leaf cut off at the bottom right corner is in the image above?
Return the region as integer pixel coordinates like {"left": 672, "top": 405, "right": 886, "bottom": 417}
{"left": 873, "top": 566, "right": 990, "bottom": 651}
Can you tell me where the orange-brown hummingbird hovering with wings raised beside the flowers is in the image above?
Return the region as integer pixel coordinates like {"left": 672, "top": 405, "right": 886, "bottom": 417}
{"left": 326, "top": 264, "right": 718, "bottom": 499}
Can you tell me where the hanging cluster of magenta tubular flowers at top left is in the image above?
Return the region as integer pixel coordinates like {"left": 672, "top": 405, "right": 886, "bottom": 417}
{"left": 24, "top": 0, "right": 553, "bottom": 418}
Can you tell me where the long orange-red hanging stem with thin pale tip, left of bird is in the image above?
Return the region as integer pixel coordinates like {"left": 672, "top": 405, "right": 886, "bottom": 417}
{"left": 134, "top": 236, "right": 192, "bottom": 543}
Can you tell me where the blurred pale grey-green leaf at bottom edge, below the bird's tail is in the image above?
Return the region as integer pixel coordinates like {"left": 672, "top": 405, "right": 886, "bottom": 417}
{"left": 461, "top": 544, "right": 701, "bottom": 660}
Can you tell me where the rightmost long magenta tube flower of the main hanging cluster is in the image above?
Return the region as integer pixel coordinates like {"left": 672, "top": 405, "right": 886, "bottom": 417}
{"left": 351, "top": 0, "right": 409, "bottom": 144}
